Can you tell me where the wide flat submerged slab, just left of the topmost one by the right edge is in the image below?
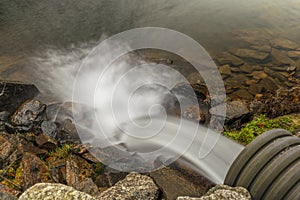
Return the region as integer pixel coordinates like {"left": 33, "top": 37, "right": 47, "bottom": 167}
{"left": 230, "top": 49, "right": 269, "bottom": 61}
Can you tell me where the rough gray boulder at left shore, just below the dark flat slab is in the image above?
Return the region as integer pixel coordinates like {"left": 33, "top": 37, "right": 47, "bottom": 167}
{"left": 11, "top": 100, "right": 46, "bottom": 126}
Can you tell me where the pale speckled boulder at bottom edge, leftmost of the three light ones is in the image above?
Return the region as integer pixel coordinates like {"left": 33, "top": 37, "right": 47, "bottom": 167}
{"left": 19, "top": 183, "right": 95, "bottom": 200}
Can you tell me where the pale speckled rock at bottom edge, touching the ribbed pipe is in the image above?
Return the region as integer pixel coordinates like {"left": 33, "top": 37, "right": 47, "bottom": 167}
{"left": 177, "top": 185, "right": 251, "bottom": 200}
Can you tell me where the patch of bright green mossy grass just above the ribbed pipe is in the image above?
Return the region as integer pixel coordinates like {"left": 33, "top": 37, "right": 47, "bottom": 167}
{"left": 224, "top": 115, "right": 299, "bottom": 145}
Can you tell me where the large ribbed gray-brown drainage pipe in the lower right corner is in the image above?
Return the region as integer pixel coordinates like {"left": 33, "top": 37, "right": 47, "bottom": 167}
{"left": 224, "top": 129, "right": 300, "bottom": 200}
